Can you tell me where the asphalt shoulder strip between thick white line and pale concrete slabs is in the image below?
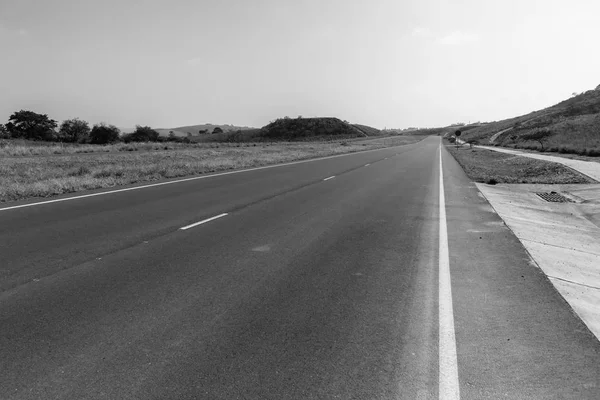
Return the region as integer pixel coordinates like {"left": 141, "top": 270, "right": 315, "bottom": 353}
{"left": 443, "top": 145, "right": 600, "bottom": 399}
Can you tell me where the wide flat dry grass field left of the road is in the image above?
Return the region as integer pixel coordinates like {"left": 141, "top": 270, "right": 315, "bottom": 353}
{"left": 0, "top": 136, "right": 423, "bottom": 202}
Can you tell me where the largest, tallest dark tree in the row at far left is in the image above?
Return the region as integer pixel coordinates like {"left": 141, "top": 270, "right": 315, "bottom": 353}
{"left": 6, "top": 110, "right": 57, "bottom": 140}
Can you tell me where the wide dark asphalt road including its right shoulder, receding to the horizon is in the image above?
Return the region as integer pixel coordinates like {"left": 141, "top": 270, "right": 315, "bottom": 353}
{"left": 0, "top": 137, "right": 600, "bottom": 399}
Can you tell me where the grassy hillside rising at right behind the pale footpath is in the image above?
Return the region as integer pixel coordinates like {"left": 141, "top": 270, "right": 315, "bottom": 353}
{"left": 462, "top": 87, "right": 600, "bottom": 156}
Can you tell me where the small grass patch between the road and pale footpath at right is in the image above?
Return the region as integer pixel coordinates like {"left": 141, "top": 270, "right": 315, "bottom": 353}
{"left": 447, "top": 146, "right": 595, "bottom": 184}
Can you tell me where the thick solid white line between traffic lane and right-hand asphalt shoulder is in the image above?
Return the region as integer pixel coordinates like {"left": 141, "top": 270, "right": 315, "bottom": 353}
{"left": 438, "top": 145, "right": 460, "bottom": 400}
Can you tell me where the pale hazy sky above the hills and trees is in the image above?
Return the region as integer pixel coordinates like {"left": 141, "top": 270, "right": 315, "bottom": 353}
{"left": 0, "top": 0, "right": 600, "bottom": 128}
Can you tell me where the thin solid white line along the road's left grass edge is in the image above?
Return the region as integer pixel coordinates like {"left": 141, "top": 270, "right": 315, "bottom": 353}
{"left": 0, "top": 142, "right": 412, "bottom": 211}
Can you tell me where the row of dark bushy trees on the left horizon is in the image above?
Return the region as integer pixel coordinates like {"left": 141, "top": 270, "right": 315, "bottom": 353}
{"left": 0, "top": 110, "right": 178, "bottom": 144}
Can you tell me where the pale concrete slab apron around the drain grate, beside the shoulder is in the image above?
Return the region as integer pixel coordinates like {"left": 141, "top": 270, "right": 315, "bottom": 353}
{"left": 477, "top": 184, "right": 600, "bottom": 338}
